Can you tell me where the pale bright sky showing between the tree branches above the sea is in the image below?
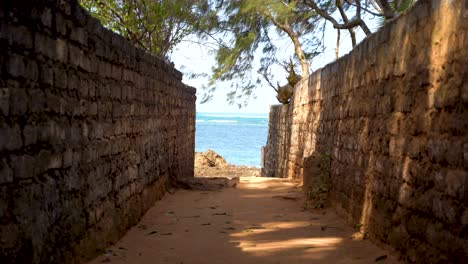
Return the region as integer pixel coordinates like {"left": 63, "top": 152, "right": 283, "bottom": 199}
{"left": 171, "top": 18, "right": 372, "bottom": 114}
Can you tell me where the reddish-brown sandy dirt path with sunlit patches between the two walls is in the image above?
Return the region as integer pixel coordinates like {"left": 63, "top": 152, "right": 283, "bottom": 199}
{"left": 89, "top": 177, "right": 399, "bottom": 264}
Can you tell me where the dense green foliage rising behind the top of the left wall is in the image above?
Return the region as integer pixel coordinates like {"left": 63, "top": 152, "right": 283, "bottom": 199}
{"left": 80, "top": 0, "right": 216, "bottom": 57}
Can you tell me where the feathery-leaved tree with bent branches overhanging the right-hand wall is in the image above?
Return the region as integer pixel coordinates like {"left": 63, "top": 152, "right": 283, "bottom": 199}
{"left": 204, "top": 0, "right": 416, "bottom": 105}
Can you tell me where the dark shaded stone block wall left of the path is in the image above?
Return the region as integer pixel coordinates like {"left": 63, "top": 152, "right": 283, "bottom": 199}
{"left": 0, "top": 0, "right": 195, "bottom": 263}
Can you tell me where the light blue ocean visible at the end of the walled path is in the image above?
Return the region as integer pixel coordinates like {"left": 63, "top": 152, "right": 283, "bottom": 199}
{"left": 195, "top": 113, "right": 268, "bottom": 167}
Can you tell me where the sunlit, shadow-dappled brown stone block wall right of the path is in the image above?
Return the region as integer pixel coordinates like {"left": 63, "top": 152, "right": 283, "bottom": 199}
{"left": 270, "top": 0, "right": 468, "bottom": 263}
